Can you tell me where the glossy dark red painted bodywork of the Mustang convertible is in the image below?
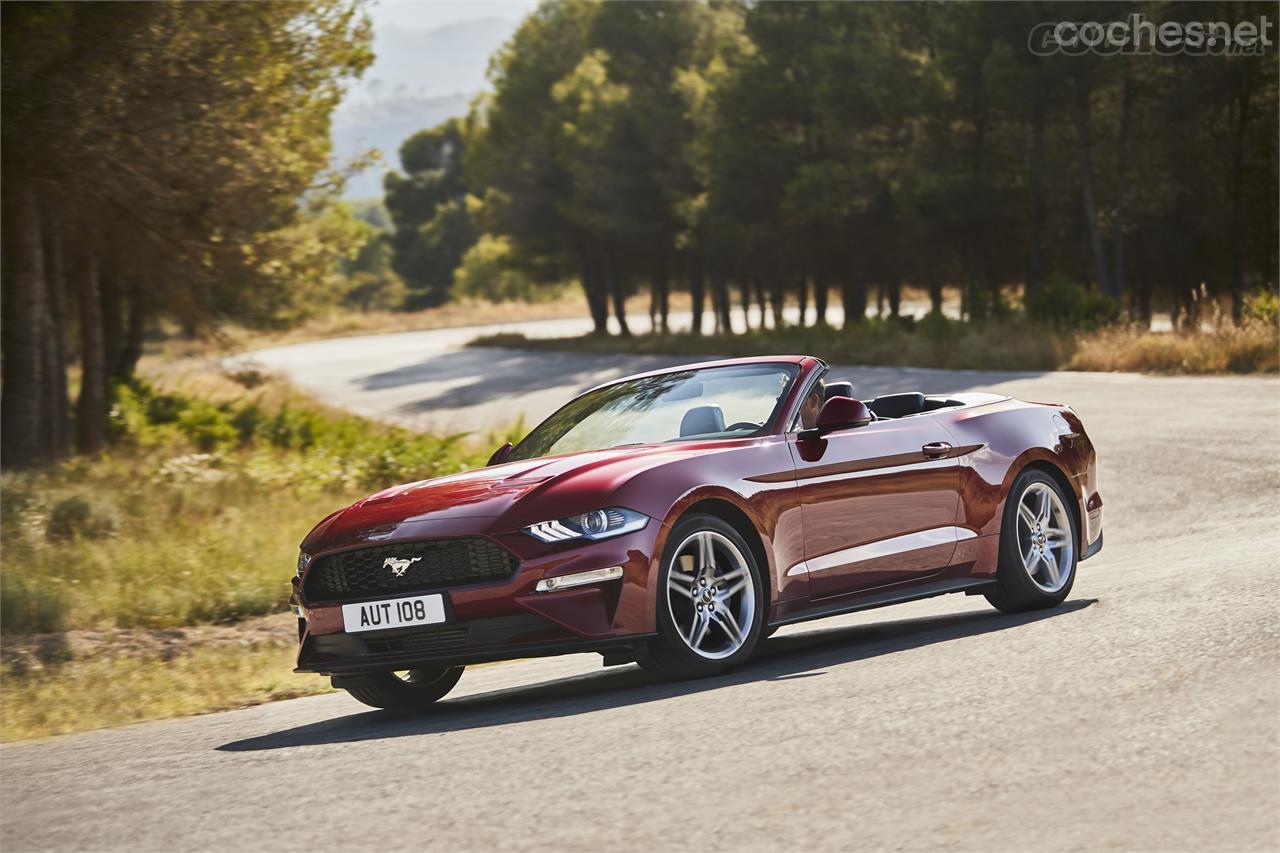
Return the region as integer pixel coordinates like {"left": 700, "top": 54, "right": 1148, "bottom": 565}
{"left": 293, "top": 356, "right": 1102, "bottom": 672}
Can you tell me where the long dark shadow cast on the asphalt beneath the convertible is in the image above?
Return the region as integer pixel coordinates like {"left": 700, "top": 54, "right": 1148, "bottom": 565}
{"left": 218, "top": 598, "right": 1097, "bottom": 752}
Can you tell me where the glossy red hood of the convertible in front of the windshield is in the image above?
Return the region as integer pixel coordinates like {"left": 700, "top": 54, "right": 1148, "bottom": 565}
{"left": 302, "top": 441, "right": 742, "bottom": 553}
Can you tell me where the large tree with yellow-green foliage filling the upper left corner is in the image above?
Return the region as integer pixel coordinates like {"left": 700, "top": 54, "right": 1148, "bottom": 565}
{"left": 0, "top": 0, "right": 370, "bottom": 465}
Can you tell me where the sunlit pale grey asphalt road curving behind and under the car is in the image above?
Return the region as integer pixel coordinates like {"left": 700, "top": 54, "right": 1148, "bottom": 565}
{"left": 0, "top": 315, "right": 1280, "bottom": 852}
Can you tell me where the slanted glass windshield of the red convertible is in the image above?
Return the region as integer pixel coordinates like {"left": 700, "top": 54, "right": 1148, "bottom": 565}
{"left": 509, "top": 362, "right": 799, "bottom": 460}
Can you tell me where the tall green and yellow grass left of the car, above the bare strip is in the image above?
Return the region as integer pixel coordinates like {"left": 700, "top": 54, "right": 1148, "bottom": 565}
{"left": 0, "top": 376, "right": 509, "bottom": 634}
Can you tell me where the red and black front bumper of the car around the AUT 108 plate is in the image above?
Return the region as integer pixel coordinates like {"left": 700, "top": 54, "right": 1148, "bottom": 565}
{"left": 293, "top": 521, "right": 667, "bottom": 674}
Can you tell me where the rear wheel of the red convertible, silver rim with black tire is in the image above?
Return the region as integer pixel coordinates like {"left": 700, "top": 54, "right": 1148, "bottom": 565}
{"left": 986, "top": 469, "right": 1080, "bottom": 613}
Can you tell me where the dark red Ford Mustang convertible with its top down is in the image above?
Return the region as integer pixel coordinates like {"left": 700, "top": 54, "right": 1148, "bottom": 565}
{"left": 293, "top": 356, "right": 1102, "bottom": 708}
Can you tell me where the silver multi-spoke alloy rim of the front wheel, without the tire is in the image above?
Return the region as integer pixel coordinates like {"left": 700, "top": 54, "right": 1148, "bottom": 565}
{"left": 667, "top": 530, "right": 755, "bottom": 661}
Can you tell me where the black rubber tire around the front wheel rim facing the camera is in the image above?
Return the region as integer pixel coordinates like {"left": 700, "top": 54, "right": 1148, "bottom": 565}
{"left": 636, "top": 514, "right": 768, "bottom": 679}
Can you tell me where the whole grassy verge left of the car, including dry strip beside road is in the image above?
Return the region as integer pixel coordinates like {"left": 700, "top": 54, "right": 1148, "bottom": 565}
{"left": 0, "top": 371, "right": 518, "bottom": 738}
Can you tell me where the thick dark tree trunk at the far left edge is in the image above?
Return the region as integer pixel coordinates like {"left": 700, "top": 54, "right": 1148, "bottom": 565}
{"left": 0, "top": 183, "right": 50, "bottom": 467}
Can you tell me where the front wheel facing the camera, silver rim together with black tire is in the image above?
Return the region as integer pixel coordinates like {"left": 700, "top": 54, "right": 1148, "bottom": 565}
{"left": 639, "top": 515, "right": 767, "bottom": 679}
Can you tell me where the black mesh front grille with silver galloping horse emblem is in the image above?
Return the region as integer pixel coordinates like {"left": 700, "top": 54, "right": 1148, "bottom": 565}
{"left": 303, "top": 537, "right": 520, "bottom": 602}
